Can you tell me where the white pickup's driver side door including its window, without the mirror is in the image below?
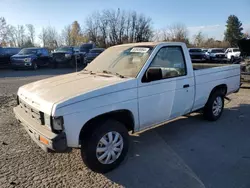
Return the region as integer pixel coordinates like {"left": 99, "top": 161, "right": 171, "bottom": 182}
{"left": 138, "top": 46, "right": 194, "bottom": 130}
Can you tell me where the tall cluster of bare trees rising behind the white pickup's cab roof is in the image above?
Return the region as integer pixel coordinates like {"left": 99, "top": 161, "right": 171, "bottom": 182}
{"left": 85, "top": 9, "right": 153, "bottom": 47}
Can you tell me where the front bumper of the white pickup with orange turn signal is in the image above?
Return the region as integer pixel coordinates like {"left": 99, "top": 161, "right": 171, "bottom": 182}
{"left": 14, "top": 106, "right": 69, "bottom": 153}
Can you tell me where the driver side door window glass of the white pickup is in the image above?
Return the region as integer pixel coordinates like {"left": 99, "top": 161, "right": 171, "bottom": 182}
{"left": 150, "top": 46, "right": 187, "bottom": 79}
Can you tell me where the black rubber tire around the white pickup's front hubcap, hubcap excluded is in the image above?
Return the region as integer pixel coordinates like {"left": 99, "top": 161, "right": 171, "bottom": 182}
{"left": 81, "top": 119, "right": 129, "bottom": 173}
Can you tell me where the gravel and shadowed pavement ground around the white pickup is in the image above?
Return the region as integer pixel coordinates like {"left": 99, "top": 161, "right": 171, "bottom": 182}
{"left": 0, "top": 69, "right": 250, "bottom": 188}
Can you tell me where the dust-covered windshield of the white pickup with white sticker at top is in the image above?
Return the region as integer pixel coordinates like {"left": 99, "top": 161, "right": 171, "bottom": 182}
{"left": 85, "top": 44, "right": 153, "bottom": 78}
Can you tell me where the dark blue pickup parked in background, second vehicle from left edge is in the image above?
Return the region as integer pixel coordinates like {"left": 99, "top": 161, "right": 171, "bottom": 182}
{"left": 10, "top": 48, "right": 50, "bottom": 70}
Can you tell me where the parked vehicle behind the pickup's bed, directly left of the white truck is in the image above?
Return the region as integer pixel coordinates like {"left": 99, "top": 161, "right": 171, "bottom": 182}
{"left": 206, "top": 48, "right": 227, "bottom": 62}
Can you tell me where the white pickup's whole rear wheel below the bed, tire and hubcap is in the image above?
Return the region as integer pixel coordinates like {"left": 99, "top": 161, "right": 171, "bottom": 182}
{"left": 203, "top": 90, "right": 224, "bottom": 121}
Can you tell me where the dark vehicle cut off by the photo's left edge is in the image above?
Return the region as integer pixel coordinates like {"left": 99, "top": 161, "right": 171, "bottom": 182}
{"left": 0, "top": 47, "right": 21, "bottom": 67}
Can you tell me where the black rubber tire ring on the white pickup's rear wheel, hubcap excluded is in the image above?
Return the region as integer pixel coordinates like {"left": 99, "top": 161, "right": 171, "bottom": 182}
{"left": 203, "top": 89, "right": 224, "bottom": 121}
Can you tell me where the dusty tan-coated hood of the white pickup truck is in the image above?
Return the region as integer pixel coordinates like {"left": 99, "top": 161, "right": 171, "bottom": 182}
{"left": 18, "top": 72, "right": 135, "bottom": 114}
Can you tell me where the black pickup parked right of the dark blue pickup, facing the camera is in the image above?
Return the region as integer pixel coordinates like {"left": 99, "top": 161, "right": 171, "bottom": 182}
{"left": 52, "top": 46, "right": 79, "bottom": 68}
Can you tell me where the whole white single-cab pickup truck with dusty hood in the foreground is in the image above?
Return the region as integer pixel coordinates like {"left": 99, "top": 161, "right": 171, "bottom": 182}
{"left": 14, "top": 42, "right": 240, "bottom": 173}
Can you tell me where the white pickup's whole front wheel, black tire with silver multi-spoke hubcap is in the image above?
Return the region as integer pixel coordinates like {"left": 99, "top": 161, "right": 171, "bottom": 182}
{"left": 81, "top": 119, "right": 129, "bottom": 173}
